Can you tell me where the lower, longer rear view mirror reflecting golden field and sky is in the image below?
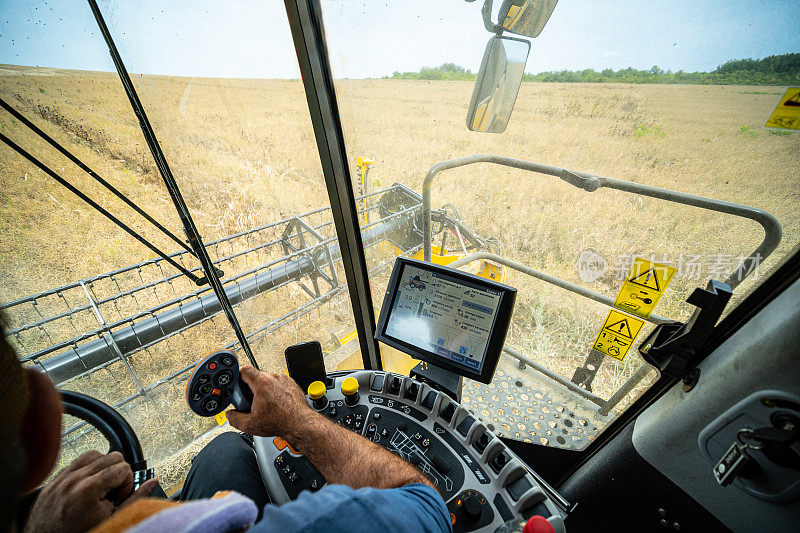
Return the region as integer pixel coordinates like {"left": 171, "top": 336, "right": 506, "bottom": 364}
{"left": 467, "top": 37, "right": 531, "bottom": 133}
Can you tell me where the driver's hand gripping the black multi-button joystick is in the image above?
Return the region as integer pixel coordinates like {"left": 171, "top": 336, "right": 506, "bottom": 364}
{"left": 226, "top": 365, "right": 313, "bottom": 437}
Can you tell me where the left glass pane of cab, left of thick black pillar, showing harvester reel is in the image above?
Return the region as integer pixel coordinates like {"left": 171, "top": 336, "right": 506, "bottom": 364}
{"left": 0, "top": 1, "right": 360, "bottom": 491}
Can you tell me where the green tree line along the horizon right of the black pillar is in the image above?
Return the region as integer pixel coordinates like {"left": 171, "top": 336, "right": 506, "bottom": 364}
{"left": 384, "top": 53, "right": 800, "bottom": 85}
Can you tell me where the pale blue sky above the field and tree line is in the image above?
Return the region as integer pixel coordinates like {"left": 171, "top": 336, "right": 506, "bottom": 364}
{"left": 0, "top": 0, "right": 800, "bottom": 78}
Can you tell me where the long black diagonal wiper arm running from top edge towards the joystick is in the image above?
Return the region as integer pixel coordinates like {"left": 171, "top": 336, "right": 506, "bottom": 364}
{"left": 88, "top": 0, "right": 258, "bottom": 368}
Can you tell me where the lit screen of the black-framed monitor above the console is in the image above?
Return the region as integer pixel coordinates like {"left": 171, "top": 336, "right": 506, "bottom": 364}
{"left": 386, "top": 265, "right": 502, "bottom": 373}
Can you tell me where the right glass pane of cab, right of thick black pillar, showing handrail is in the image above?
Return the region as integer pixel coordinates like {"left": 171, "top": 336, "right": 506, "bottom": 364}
{"left": 322, "top": 0, "right": 800, "bottom": 442}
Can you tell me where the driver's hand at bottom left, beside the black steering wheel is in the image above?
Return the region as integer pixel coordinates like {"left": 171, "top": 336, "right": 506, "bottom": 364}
{"left": 25, "top": 450, "right": 158, "bottom": 533}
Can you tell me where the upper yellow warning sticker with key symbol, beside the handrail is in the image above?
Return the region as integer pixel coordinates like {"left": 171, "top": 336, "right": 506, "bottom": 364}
{"left": 614, "top": 257, "right": 676, "bottom": 318}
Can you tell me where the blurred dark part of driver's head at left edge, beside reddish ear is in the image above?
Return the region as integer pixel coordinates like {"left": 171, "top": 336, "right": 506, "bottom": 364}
{"left": 0, "top": 318, "right": 28, "bottom": 454}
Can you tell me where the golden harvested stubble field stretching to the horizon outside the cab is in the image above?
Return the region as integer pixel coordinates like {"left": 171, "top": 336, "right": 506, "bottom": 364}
{"left": 0, "top": 66, "right": 800, "bottom": 488}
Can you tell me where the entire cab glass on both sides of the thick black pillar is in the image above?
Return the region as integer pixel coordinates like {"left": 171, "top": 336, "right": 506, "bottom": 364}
{"left": 0, "top": 0, "right": 800, "bottom": 488}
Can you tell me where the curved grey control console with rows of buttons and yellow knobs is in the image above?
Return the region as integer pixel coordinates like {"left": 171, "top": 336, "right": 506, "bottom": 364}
{"left": 254, "top": 370, "right": 569, "bottom": 533}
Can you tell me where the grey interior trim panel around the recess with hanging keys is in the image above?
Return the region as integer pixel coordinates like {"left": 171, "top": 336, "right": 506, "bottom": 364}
{"left": 636, "top": 281, "right": 800, "bottom": 532}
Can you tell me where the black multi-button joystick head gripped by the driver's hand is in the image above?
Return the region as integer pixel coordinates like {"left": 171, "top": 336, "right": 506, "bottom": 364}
{"left": 186, "top": 350, "right": 253, "bottom": 416}
